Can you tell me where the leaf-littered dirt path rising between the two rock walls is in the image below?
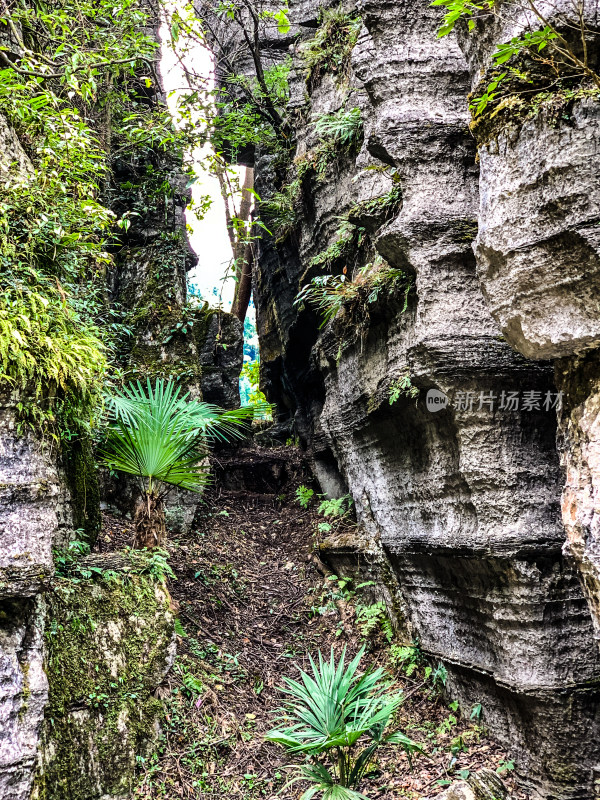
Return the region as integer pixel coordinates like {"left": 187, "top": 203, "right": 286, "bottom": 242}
{"left": 99, "top": 447, "right": 526, "bottom": 800}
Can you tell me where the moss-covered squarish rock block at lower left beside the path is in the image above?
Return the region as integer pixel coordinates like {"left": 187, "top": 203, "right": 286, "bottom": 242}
{"left": 32, "top": 554, "right": 174, "bottom": 800}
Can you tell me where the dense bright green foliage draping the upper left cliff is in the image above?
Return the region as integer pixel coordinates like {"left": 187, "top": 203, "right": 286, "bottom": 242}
{"left": 0, "top": 0, "right": 193, "bottom": 437}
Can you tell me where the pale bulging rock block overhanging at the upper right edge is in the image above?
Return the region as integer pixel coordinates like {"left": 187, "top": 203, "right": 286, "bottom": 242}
{"left": 475, "top": 99, "right": 600, "bottom": 359}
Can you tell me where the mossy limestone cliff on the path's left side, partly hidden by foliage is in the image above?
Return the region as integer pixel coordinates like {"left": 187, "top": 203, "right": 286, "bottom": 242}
{"left": 0, "top": 15, "right": 242, "bottom": 800}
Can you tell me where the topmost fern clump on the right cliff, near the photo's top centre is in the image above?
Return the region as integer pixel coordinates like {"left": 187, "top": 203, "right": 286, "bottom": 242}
{"left": 300, "top": 5, "right": 361, "bottom": 88}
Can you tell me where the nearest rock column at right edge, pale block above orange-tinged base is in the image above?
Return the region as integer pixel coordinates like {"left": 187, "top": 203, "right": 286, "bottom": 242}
{"left": 452, "top": 2, "right": 600, "bottom": 664}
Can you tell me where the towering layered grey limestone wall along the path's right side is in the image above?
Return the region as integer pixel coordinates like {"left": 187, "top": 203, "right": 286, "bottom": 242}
{"left": 223, "top": 0, "right": 600, "bottom": 800}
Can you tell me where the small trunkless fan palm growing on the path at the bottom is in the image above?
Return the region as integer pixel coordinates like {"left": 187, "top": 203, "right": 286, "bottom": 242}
{"left": 266, "top": 647, "right": 422, "bottom": 800}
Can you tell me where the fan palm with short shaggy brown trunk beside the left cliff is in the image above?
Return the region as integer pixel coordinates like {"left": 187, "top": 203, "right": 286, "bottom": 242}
{"left": 100, "top": 379, "right": 256, "bottom": 548}
